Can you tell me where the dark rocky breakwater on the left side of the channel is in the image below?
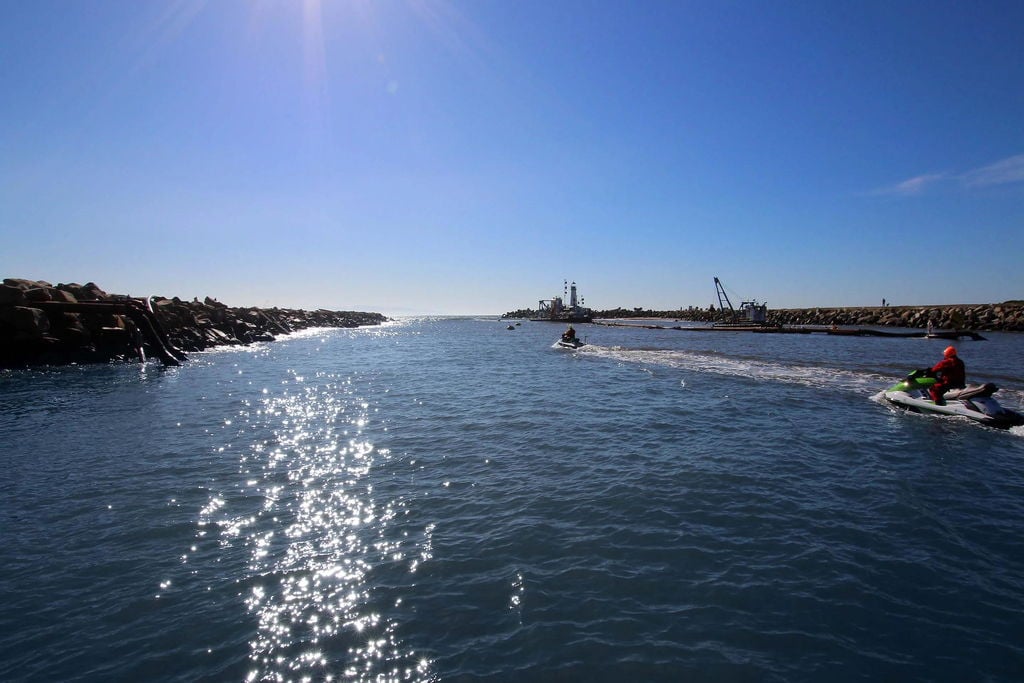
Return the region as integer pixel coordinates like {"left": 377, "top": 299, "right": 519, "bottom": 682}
{"left": 0, "top": 279, "right": 387, "bottom": 368}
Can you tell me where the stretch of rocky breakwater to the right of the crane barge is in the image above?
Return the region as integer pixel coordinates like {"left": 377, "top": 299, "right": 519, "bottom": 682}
{"left": 768, "top": 301, "right": 1024, "bottom": 332}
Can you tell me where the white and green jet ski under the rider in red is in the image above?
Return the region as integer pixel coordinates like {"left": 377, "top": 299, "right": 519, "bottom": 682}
{"left": 882, "top": 370, "right": 1024, "bottom": 429}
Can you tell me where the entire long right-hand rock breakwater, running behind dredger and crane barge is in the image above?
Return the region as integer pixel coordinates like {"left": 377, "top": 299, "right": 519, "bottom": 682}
{"left": 502, "top": 300, "right": 1024, "bottom": 332}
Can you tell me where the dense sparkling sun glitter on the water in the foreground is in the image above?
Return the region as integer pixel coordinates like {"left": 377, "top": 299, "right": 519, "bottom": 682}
{"left": 201, "top": 371, "right": 431, "bottom": 681}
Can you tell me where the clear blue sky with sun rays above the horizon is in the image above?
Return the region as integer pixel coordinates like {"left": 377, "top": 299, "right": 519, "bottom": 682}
{"left": 0, "top": 0, "right": 1024, "bottom": 314}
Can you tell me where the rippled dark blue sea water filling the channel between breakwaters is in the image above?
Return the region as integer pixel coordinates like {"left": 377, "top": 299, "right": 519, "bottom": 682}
{"left": 0, "top": 318, "right": 1024, "bottom": 682}
